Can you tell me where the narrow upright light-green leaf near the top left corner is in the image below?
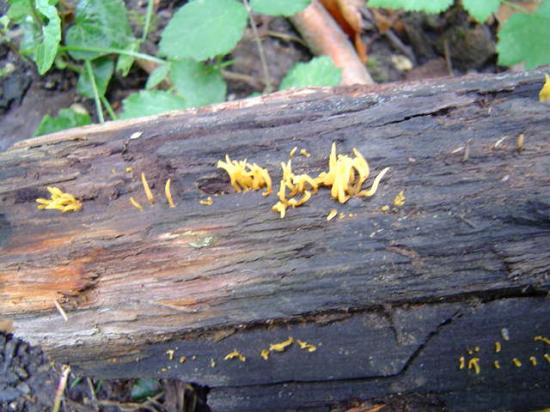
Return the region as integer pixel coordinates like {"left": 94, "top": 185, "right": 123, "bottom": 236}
{"left": 34, "top": 0, "right": 61, "bottom": 74}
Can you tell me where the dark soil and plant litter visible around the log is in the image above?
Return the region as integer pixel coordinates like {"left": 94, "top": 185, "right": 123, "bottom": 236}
{"left": 0, "top": 0, "right": 508, "bottom": 412}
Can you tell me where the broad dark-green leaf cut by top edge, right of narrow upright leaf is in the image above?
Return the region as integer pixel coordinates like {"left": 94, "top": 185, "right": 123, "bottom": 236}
{"left": 65, "top": 0, "right": 134, "bottom": 60}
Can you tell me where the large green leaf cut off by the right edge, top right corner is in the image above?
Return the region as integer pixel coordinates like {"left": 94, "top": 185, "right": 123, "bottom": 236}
{"left": 497, "top": 0, "right": 550, "bottom": 69}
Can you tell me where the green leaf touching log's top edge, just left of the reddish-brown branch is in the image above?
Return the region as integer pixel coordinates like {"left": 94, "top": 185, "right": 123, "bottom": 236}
{"left": 279, "top": 56, "right": 342, "bottom": 90}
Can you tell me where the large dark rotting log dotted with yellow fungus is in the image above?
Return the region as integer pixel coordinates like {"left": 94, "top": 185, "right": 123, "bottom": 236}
{"left": 0, "top": 72, "right": 550, "bottom": 411}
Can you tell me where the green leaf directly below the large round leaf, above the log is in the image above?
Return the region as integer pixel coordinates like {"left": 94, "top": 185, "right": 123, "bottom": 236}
{"left": 170, "top": 59, "right": 227, "bottom": 107}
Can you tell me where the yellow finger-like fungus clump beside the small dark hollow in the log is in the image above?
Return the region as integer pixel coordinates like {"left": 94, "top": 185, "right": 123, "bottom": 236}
{"left": 217, "top": 155, "right": 272, "bottom": 196}
